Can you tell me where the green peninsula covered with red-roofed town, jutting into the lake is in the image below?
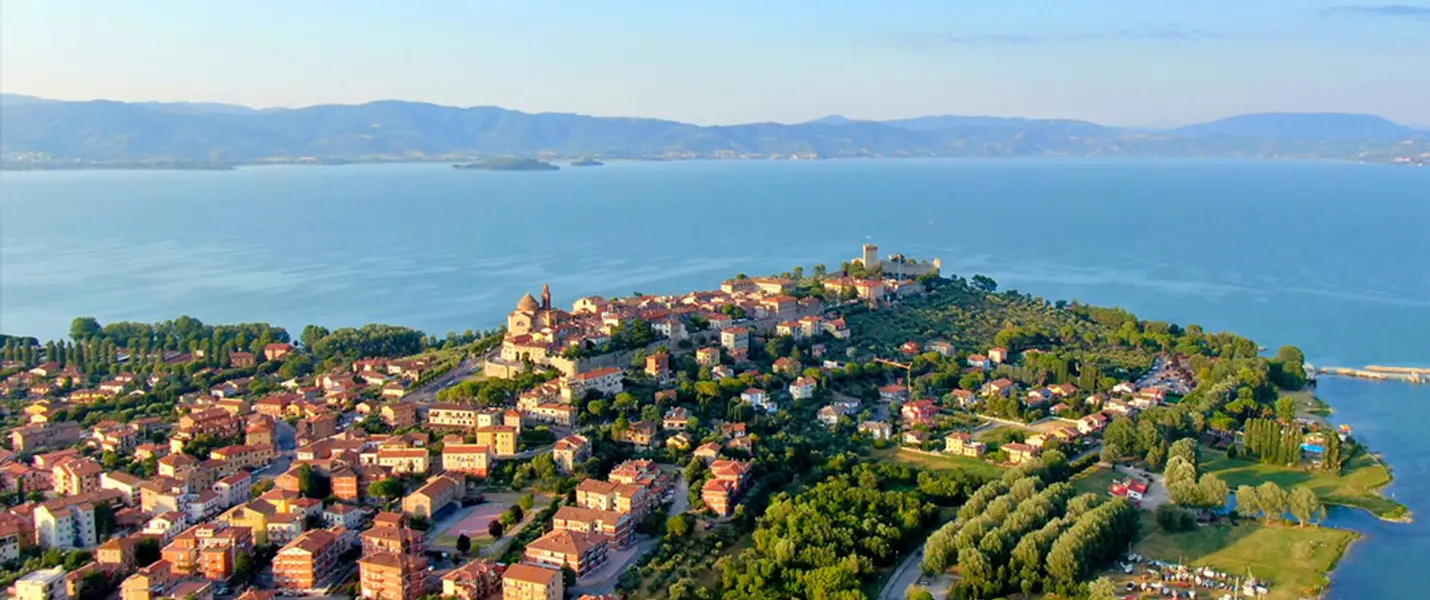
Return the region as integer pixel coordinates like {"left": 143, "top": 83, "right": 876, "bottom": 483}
{"left": 0, "top": 244, "right": 1410, "bottom": 600}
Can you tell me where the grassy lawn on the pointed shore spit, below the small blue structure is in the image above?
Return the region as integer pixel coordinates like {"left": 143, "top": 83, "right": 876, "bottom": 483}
{"left": 1201, "top": 449, "right": 1409, "bottom": 519}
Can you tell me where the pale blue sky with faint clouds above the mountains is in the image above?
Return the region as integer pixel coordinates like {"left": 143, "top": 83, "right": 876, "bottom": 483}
{"left": 0, "top": 0, "right": 1430, "bottom": 126}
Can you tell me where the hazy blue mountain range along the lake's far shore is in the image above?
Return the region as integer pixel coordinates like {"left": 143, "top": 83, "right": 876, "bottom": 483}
{"left": 0, "top": 94, "right": 1430, "bottom": 167}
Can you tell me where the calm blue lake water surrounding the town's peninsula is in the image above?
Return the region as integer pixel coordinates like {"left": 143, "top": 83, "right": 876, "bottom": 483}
{"left": 0, "top": 160, "right": 1430, "bottom": 599}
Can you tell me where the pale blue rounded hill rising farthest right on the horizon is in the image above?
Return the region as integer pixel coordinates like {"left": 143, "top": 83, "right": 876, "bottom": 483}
{"left": 1171, "top": 113, "right": 1416, "bottom": 140}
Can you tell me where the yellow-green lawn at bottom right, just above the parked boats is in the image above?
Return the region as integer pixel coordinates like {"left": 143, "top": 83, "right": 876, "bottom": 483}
{"left": 1133, "top": 523, "right": 1360, "bottom": 600}
